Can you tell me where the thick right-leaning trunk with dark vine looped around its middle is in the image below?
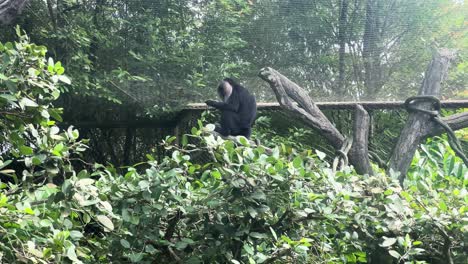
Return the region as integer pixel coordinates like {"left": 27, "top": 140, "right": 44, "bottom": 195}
{"left": 389, "top": 49, "right": 455, "bottom": 183}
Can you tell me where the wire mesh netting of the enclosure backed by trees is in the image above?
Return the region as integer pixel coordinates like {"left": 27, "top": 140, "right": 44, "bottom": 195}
{"left": 0, "top": 0, "right": 468, "bottom": 163}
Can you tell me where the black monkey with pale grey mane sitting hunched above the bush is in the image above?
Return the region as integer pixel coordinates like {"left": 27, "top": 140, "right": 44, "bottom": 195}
{"left": 205, "top": 78, "right": 257, "bottom": 138}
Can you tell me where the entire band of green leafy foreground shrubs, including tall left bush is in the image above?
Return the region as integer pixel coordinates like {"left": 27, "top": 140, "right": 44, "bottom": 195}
{"left": 0, "top": 30, "right": 468, "bottom": 263}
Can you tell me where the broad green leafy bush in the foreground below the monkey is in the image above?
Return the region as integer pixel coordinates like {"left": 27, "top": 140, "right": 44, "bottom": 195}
{"left": 95, "top": 124, "right": 467, "bottom": 263}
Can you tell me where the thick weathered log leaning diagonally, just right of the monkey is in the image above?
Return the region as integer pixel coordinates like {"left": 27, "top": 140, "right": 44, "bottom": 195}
{"left": 259, "top": 67, "right": 344, "bottom": 149}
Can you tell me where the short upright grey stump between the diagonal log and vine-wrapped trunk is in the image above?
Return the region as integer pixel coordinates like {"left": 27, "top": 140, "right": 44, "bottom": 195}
{"left": 349, "top": 105, "right": 374, "bottom": 175}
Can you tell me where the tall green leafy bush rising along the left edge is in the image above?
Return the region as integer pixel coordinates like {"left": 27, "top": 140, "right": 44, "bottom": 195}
{"left": 0, "top": 29, "right": 112, "bottom": 263}
